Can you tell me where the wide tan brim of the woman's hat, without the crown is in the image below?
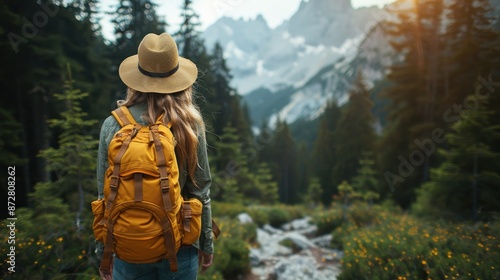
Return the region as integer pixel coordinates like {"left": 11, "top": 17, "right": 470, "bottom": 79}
{"left": 118, "top": 54, "right": 198, "bottom": 94}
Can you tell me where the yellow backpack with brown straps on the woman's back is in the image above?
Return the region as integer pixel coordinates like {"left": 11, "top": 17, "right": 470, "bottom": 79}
{"left": 92, "top": 106, "right": 202, "bottom": 274}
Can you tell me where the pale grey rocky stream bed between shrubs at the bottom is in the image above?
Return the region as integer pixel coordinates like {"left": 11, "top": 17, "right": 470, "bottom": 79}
{"left": 250, "top": 217, "right": 343, "bottom": 280}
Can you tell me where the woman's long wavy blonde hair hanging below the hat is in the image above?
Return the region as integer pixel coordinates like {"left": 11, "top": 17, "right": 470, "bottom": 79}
{"left": 117, "top": 87, "right": 205, "bottom": 185}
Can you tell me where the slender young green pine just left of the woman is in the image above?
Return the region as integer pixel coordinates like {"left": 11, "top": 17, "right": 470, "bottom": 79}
{"left": 36, "top": 65, "right": 97, "bottom": 230}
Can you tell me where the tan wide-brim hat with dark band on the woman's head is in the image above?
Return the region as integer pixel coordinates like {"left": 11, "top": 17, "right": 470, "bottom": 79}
{"left": 118, "top": 33, "right": 198, "bottom": 94}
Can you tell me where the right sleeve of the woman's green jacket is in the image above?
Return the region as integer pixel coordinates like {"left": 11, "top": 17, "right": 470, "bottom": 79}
{"left": 186, "top": 132, "right": 214, "bottom": 254}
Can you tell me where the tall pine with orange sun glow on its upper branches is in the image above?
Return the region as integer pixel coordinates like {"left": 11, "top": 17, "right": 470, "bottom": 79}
{"left": 377, "top": 0, "right": 445, "bottom": 207}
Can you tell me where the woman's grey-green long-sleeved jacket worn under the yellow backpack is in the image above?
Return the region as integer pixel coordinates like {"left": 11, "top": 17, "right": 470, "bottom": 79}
{"left": 96, "top": 104, "right": 214, "bottom": 255}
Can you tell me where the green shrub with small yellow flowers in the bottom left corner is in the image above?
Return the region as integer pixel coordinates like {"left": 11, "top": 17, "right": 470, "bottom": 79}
{"left": 0, "top": 208, "right": 99, "bottom": 280}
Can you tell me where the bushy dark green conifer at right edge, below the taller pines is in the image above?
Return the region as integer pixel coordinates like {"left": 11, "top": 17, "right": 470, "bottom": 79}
{"left": 413, "top": 96, "right": 500, "bottom": 221}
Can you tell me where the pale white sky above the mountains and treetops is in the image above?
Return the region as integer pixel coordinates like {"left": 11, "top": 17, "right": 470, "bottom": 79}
{"left": 101, "top": 0, "right": 394, "bottom": 39}
